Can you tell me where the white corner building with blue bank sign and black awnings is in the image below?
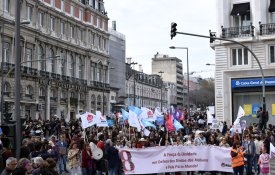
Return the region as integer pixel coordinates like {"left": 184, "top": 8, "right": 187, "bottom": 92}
{"left": 215, "top": 0, "right": 275, "bottom": 124}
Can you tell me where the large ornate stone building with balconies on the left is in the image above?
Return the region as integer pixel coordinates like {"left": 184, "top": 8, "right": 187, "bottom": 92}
{"left": 0, "top": 0, "right": 110, "bottom": 119}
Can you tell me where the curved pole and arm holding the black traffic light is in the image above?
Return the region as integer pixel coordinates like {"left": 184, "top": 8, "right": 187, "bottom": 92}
{"left": 171, "top": 28, "right": 266, "bottom": 112}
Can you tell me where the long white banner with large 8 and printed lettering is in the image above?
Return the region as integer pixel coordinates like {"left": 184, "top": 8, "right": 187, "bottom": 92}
{"left": 119, "top": 145, "right": 233, "bottom": 174}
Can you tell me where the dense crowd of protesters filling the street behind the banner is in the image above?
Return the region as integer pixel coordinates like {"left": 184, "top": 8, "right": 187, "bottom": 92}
{"left": 1, "top": 109, "right": 275, "bottom": 175}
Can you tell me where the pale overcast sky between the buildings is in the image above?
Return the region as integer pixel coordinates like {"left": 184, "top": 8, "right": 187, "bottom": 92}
{"left": 104, "top": 0, "right": 217, "bottom": 78}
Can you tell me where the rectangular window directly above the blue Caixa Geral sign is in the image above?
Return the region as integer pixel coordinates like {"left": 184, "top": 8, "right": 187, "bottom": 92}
{"left": 231, "top": 48, "right": 248, "bottom": 66}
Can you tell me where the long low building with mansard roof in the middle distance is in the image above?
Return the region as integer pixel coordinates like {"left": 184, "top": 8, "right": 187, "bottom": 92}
{"left": 125, "top": 60, "right": 168, "bottom": 109}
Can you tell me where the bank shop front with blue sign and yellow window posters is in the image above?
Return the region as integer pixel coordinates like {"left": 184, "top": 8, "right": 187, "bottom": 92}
{"left": 231, "top": 77, "right": 275, "bottom": 125}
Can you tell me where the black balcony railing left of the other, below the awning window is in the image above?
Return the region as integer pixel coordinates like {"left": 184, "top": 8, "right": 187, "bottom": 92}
{"left": 221, "top": 25, "right": 255, "bottom": 38}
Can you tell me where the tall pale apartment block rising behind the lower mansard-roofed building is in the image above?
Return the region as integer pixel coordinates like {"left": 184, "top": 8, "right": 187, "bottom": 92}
{"left": 152, "top": 53, "right": 184, "bottom": 108}
